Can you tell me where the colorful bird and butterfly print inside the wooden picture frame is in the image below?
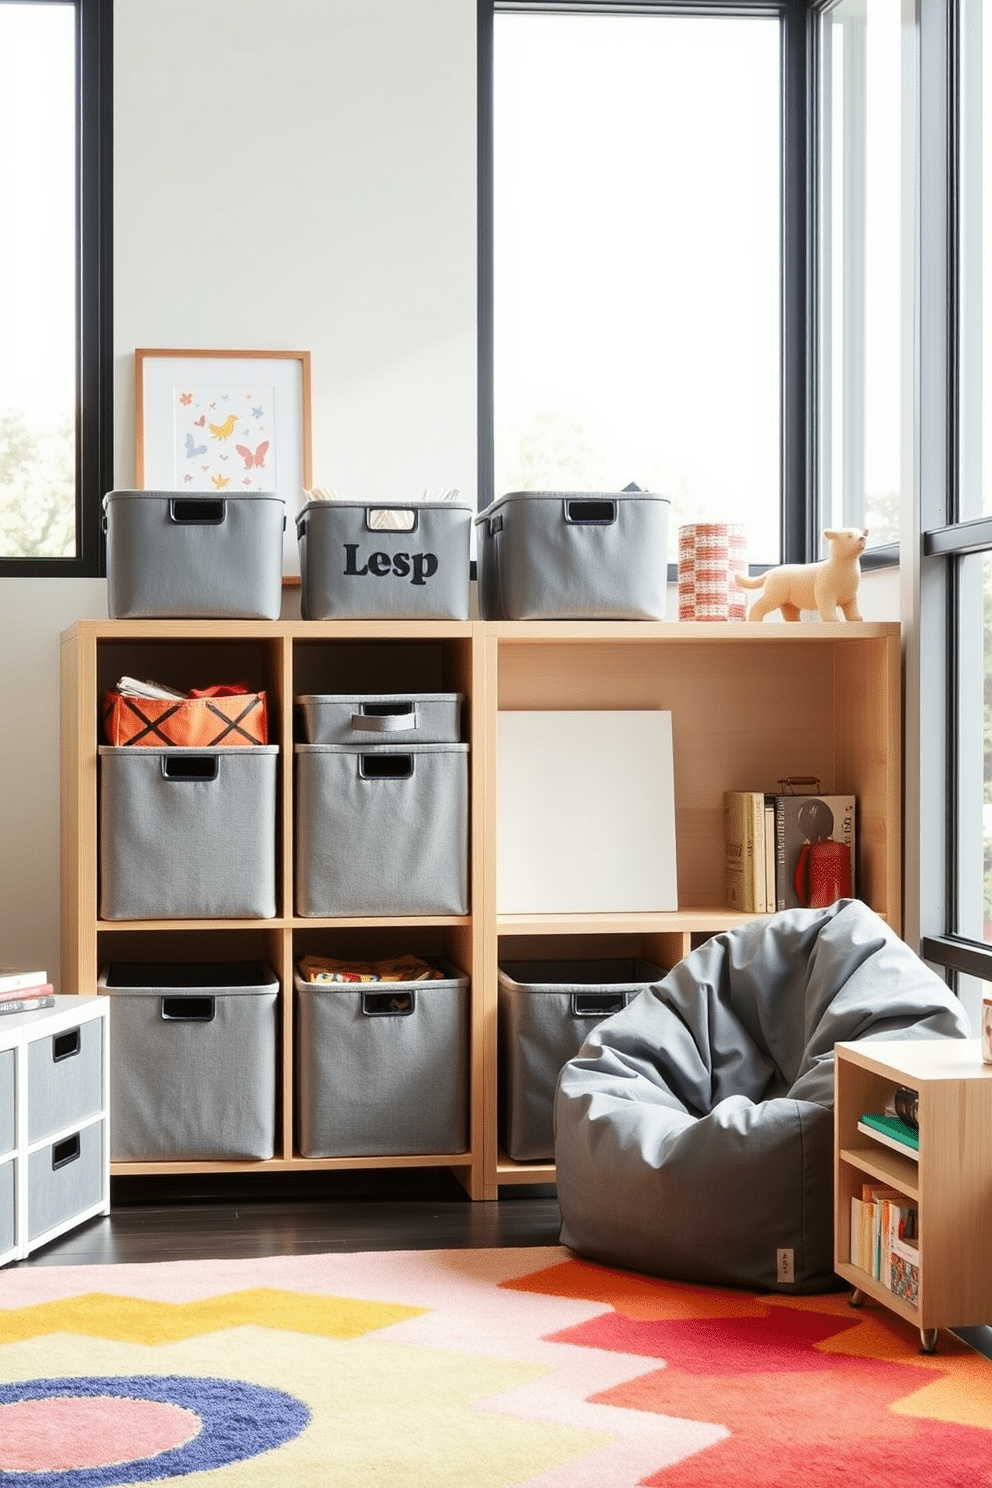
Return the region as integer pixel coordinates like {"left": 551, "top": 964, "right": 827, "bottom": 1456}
{"left": 173, "top": 382, "right": 277, "bottom": 491}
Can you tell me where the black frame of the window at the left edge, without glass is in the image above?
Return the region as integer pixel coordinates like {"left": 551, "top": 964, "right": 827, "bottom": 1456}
{"left": 0, "top": 0, "right": 113, "bottom": 579}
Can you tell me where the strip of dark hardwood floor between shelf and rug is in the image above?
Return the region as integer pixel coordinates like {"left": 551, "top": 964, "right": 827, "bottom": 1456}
{"left": 16, "top": 1168, "right": 559, "bottom": 1266}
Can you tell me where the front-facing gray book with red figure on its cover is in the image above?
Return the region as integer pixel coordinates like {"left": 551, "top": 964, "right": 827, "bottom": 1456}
{"left": 772, "top": 795, "right": 857, "bottom": 909}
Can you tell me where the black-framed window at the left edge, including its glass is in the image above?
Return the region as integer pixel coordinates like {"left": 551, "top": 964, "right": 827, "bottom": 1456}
{"left": 0, "top": 0, "right": 113, "bottom": 577}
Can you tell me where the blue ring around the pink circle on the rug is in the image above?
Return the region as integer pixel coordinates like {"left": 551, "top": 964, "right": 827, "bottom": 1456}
{"left": 0, "top": 1375, "right": 311, "bottom": 1488}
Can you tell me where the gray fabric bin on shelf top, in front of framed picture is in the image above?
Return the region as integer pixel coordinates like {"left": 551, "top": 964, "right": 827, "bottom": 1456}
{"left": 104, "top": 491, "right": 286, "bottom": 620}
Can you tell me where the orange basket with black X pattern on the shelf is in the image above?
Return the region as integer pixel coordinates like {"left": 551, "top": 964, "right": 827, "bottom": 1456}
{"left": 103, "top": 690, "right": 268, "bottom": 748}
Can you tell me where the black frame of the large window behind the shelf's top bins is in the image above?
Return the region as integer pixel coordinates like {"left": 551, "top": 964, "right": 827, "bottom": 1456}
{"left": 477, "top": 0, "right": 898, "bottom": 568}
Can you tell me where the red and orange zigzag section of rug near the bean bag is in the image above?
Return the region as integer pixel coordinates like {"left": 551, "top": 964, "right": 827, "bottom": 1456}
{"left": 506, "top": 1260, "right": 992, "bottom": 1488}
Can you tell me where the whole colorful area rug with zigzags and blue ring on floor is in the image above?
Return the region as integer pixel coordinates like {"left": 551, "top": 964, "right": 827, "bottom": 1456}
{"left": 0, "top": 1248, "right": 992, "bottom": 1488}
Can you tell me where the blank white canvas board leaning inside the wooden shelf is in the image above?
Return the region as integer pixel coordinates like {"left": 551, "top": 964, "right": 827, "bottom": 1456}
{"left": 497, "top": 710, "right": 678, "bottom": 914}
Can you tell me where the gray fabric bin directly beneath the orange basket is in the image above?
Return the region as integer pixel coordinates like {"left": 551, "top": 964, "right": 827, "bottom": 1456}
{"left": 98, "top": 744, "right": 278, "bottom": 920}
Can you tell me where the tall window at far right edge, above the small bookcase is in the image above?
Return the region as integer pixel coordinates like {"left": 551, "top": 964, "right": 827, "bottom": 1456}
{"left": 919, "top": 0, "right": 992, "bottom": 1033}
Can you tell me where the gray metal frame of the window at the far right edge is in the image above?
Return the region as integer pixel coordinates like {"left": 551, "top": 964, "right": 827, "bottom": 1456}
{"left": 903, "top": 0, "right": 992, "bottom": 991}
